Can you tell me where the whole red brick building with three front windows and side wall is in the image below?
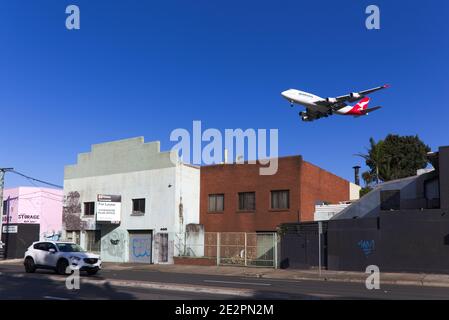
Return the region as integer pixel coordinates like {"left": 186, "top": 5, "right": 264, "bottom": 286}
{"left": 200, "top": 156, "right": 350, "bottom": 232}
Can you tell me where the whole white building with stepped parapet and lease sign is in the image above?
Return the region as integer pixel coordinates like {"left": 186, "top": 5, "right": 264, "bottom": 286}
{"left": 63, "top": 137, "right": 200, "bottom": 263}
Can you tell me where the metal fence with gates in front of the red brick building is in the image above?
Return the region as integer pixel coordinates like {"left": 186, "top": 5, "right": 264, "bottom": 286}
{"left": 175, "top": 232, "right": 278, "bottom": 268}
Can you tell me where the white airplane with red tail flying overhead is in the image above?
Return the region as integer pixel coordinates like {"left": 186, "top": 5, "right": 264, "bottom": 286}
{"left": 281, "top": 84, "right": 390, "bottom": 122}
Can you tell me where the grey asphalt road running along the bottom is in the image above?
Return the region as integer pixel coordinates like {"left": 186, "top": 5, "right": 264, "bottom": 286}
{"left": 0, "top": 265, "right": 449, "bottom": 300}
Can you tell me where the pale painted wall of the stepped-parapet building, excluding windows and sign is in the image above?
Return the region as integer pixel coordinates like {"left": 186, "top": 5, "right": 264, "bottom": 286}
{"left": 64, "top": 138, "right": 199, "bottom": 263}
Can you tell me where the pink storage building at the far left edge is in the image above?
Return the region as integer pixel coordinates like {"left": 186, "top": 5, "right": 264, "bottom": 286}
{"left": 2, "top": 187, "right": 63, "bottom": 258}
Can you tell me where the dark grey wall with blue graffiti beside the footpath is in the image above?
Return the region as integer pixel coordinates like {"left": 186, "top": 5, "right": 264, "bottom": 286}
{"left": 327, "top": 209, "right": 449, "bottom": 273}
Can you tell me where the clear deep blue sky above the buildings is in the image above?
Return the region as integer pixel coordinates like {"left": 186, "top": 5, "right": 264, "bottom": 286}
{"left": 0, "top": 0, "right": 449, "bottom": 187}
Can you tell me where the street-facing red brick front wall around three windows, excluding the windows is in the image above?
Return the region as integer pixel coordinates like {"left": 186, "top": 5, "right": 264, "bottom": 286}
{"left": 200, "top": 156, "right": 302, "bottom": 232}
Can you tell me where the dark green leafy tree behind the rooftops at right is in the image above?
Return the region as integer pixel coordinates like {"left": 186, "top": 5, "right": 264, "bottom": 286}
{"left": 358, "top": 134, "right": 430, "bottom": 186}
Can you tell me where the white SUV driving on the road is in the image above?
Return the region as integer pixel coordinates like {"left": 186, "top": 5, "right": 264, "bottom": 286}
{"left": 23, "top": 241, "right": 101, "bottom": 275}
